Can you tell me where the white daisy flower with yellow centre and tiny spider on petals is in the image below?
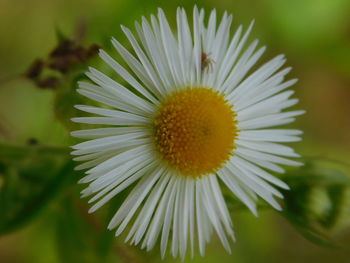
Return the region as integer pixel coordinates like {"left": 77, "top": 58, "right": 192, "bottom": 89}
{"left": 72, "top": 7, "right": 304, "bottom": 258}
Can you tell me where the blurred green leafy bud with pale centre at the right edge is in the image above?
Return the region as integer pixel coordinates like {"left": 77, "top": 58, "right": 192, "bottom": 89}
{"left": 281, "top": 159, "right": 350, "bottom": 250}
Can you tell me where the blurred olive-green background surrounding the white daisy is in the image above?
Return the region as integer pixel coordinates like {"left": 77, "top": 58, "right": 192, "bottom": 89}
{"left": 0, "top": 0, "right": 350, "bottom": 263}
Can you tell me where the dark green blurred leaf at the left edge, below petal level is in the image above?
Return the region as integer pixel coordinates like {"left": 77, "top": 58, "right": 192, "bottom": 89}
{"left": 0, "top": 142, "right": 74, "bottom": 234}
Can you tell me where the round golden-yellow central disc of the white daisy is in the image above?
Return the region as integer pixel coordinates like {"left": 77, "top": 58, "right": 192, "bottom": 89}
{"left": 154, "top": 87, "right": 237, "bottom": 177}
